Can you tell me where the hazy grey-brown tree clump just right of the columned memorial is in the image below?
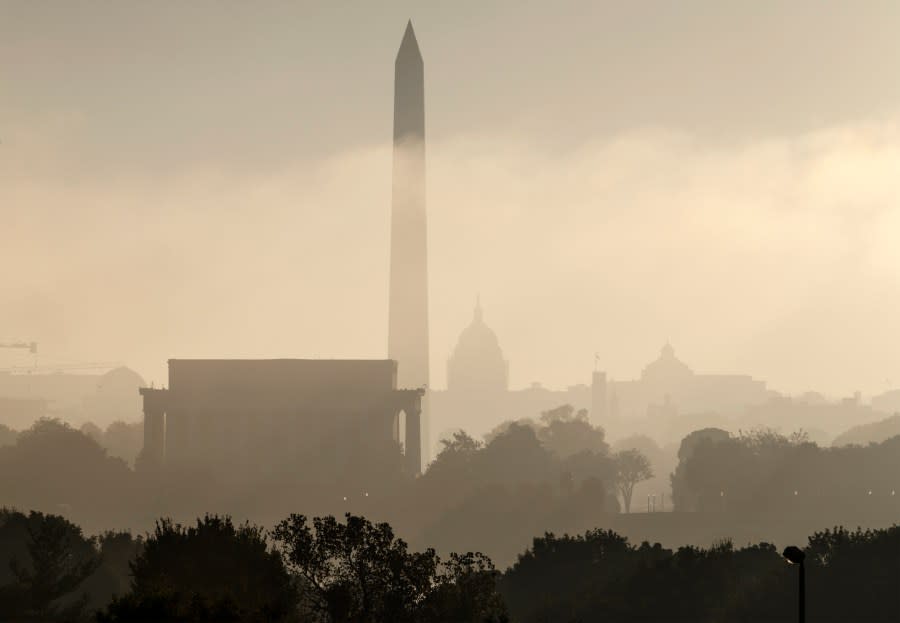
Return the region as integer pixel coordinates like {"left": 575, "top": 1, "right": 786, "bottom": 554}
{"left": 414, "top": 422, "right": 619, "bottom": 564}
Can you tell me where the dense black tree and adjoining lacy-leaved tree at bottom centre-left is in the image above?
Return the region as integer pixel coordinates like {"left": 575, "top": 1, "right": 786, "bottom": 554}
{"left": 97, "top": 514, "right": 507, "bottom": 623}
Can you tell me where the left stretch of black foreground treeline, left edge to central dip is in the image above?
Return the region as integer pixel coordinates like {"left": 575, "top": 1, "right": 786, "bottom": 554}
{"left": 0, "top": 510, "right": 508, "bottom": 623}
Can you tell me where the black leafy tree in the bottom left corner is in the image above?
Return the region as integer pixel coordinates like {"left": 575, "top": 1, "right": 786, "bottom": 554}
{"left": 0, "top": 511, "right": 100, "bottom": 621}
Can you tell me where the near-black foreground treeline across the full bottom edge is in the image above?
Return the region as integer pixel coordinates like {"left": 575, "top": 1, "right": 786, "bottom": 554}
{"left": 0, "top": 510, "right": 900, "bottom": 623}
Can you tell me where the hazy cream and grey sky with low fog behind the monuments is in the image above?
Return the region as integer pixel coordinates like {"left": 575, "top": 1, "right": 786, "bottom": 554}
{"left": 0, "top": 0, "right": 900, "bottom": 395}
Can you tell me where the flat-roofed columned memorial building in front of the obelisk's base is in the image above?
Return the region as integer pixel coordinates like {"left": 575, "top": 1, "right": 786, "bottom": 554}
{"left": 140, "top": 359, "right": 423, "bottom": 481}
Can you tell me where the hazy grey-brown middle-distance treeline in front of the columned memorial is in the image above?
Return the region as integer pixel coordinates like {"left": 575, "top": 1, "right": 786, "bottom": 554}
{"left": 0, "top": 407, "right": 900, "bottom": 566}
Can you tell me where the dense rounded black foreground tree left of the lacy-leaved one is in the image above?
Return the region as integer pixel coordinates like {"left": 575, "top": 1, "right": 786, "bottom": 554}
{"left": 100, "top": 515, "right": 297, "bottom": 622}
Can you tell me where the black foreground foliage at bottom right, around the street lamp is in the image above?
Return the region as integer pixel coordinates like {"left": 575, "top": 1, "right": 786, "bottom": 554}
{"left": 501, "top": 526, "right": 900, "bottom": 623}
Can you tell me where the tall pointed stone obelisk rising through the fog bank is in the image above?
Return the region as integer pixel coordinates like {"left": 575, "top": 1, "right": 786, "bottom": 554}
{"left": 388, "top": 21, "right": 429, "bottom": 461}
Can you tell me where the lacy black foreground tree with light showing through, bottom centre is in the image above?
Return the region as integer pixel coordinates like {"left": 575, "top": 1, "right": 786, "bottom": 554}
{"left": 273, "top": 513, "right": 506, "bottom": 623}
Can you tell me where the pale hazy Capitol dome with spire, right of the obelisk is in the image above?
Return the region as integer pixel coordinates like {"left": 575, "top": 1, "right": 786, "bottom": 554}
{"left": 447, "top": 301, "right": 509, "bottom": 393}
